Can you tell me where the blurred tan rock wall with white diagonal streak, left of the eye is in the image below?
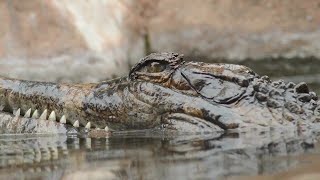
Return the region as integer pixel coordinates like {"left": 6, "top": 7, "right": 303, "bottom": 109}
{"left": 0, "top": 0, "right": 143, "bottom": 81}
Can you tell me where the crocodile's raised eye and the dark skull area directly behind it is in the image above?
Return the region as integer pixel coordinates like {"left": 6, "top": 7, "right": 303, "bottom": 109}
{"left": 129, "top": 53, "right": 259, "bottom": 104}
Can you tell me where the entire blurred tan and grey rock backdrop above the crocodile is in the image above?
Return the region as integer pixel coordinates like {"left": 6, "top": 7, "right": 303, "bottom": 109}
{"left": 0, "top": 0, "right": 320, "bottom": 83}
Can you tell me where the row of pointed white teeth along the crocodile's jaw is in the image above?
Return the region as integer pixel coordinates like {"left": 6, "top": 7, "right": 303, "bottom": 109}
{"left": 13, "top": 108, "right": 109, "bottom": 131}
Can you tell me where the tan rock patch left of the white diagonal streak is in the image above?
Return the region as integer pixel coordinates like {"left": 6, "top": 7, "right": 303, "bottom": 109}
{"left": 0, "top": 0, "right": 86, "bottom": 57}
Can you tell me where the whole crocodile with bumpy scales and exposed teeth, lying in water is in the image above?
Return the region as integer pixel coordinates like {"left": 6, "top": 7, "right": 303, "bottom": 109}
{"left": 0, "top": 53, "right": 320, "bottom": 133}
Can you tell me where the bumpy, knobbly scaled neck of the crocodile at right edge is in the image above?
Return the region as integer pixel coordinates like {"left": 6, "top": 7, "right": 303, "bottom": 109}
{"left": 232, "top": 76, "right": 320, "bottom": 127}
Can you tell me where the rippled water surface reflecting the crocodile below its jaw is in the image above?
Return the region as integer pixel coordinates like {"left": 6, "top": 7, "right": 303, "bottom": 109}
{"left": 0, "top": 130, "right": 318, "bottom": 179}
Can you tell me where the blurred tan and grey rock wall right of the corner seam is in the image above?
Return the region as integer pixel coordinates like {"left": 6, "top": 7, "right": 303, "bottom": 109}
{"left": 149, "top": 0, "right": 320, "bottom": 60}
